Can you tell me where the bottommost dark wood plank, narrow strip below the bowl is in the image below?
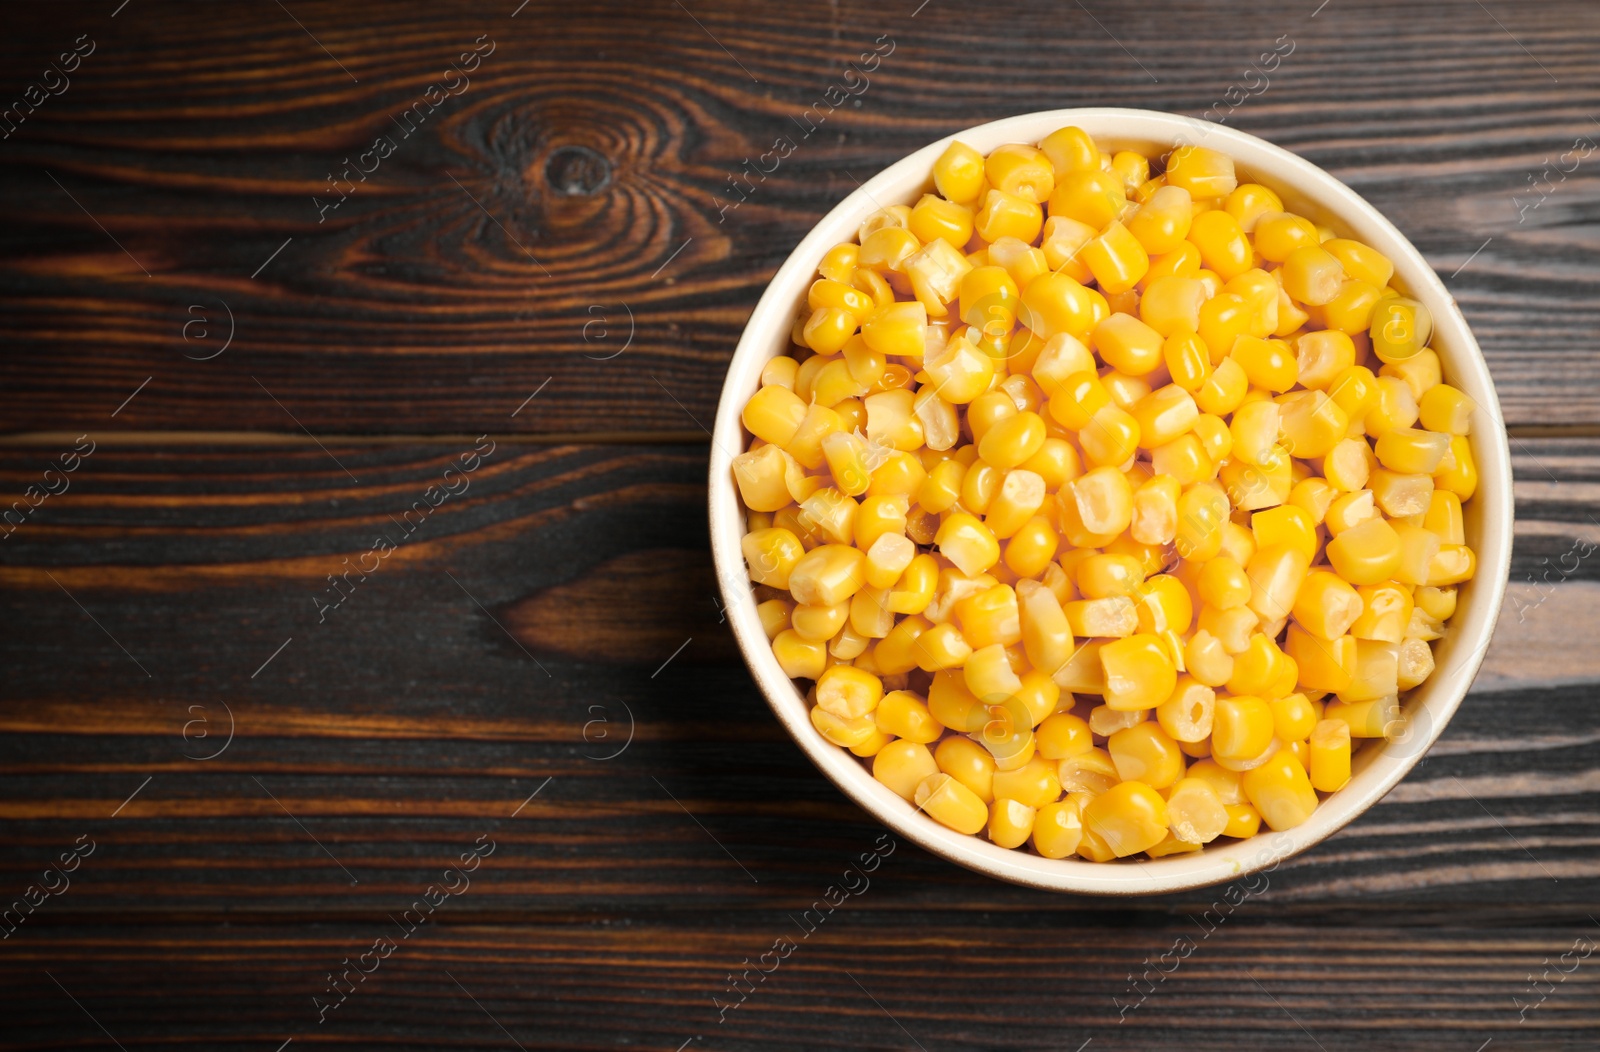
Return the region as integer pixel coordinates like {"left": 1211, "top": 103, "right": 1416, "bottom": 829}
{"left": 0, "top": 920, "right": 1600, "bottom": 1052}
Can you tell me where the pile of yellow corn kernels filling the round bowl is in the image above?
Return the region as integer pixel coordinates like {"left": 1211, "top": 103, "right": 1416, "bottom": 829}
{"left": 733, "top": 128, "right": 1477, "bottom": 862}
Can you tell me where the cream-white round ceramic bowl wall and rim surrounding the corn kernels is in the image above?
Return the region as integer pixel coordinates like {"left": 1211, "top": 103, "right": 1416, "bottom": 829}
{"left": 710, "top": 109, "right": 1512, "bottom": 895}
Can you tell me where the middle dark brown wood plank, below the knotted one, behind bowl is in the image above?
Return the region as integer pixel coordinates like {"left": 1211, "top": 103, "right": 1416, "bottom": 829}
{"left": 0, "top": 440, "right": 1600, "bottom": 921}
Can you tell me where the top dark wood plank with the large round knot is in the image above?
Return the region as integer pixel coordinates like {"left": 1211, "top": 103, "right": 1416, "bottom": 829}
{"left": 0, "top": 0, "right": 1600, "bottom": 433}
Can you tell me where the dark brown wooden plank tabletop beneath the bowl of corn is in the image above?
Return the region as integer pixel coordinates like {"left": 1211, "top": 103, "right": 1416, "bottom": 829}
{"left": 0, "top": 0, "right": 1600, "bottom": 1052}
